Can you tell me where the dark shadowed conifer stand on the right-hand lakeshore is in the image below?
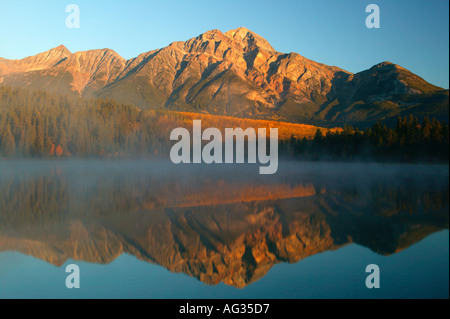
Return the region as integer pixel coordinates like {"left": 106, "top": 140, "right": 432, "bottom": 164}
{"left": 280, "top": 115, "right": 449, "bottom": 162}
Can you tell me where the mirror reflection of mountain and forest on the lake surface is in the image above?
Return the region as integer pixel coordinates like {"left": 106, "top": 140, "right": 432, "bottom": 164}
{"left": 0, "top": 160, "right": 449, "bottom": 288}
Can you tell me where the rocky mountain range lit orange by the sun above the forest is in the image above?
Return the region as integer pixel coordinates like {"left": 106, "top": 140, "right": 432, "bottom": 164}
{"left": 0, "top": 27, "right": 449, "bottom": 126}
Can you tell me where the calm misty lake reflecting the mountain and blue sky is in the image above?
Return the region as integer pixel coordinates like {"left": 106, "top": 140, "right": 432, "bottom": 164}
{"left": 0, "top": 160, "right": 449, "bottom": 299}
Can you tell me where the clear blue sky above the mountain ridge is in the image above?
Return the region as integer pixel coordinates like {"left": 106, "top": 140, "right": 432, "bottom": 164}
{"left": 0, "top": 0, "right": 449, "bottom": 88}
